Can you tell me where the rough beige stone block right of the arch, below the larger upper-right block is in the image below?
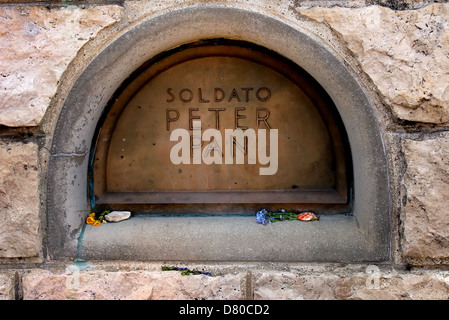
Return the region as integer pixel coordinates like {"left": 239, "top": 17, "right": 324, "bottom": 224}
{"left": 402, "top": 137, "right": 449, "bottom": 260}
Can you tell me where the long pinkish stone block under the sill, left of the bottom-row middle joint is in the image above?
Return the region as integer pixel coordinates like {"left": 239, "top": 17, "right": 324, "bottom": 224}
{"left": 22, "top": 267, "right": 242, "bottom": 300}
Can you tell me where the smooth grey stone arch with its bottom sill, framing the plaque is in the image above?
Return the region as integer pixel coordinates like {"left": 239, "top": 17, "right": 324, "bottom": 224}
{"left": 47, "top": 6, "right": 391, "bottom": 262}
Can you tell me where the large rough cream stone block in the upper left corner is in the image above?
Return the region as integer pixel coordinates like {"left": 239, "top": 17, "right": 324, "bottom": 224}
{"left": 0, "top": 6, "right": 122, "bottom": 127}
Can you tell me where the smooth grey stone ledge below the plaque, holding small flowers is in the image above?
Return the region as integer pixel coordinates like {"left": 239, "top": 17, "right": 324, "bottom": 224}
{"left": 77, "top": 215, "right": 388, "bottom": 262}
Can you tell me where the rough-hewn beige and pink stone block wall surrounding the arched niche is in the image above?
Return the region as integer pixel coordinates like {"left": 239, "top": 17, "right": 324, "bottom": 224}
{"left": 0, "top": 0, "right": 449, "bottom": 300}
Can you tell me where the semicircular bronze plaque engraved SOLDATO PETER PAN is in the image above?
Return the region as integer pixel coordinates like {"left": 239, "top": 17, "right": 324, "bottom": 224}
{"left": 94, "top": 45, "right": 347, "bottom": 204}
